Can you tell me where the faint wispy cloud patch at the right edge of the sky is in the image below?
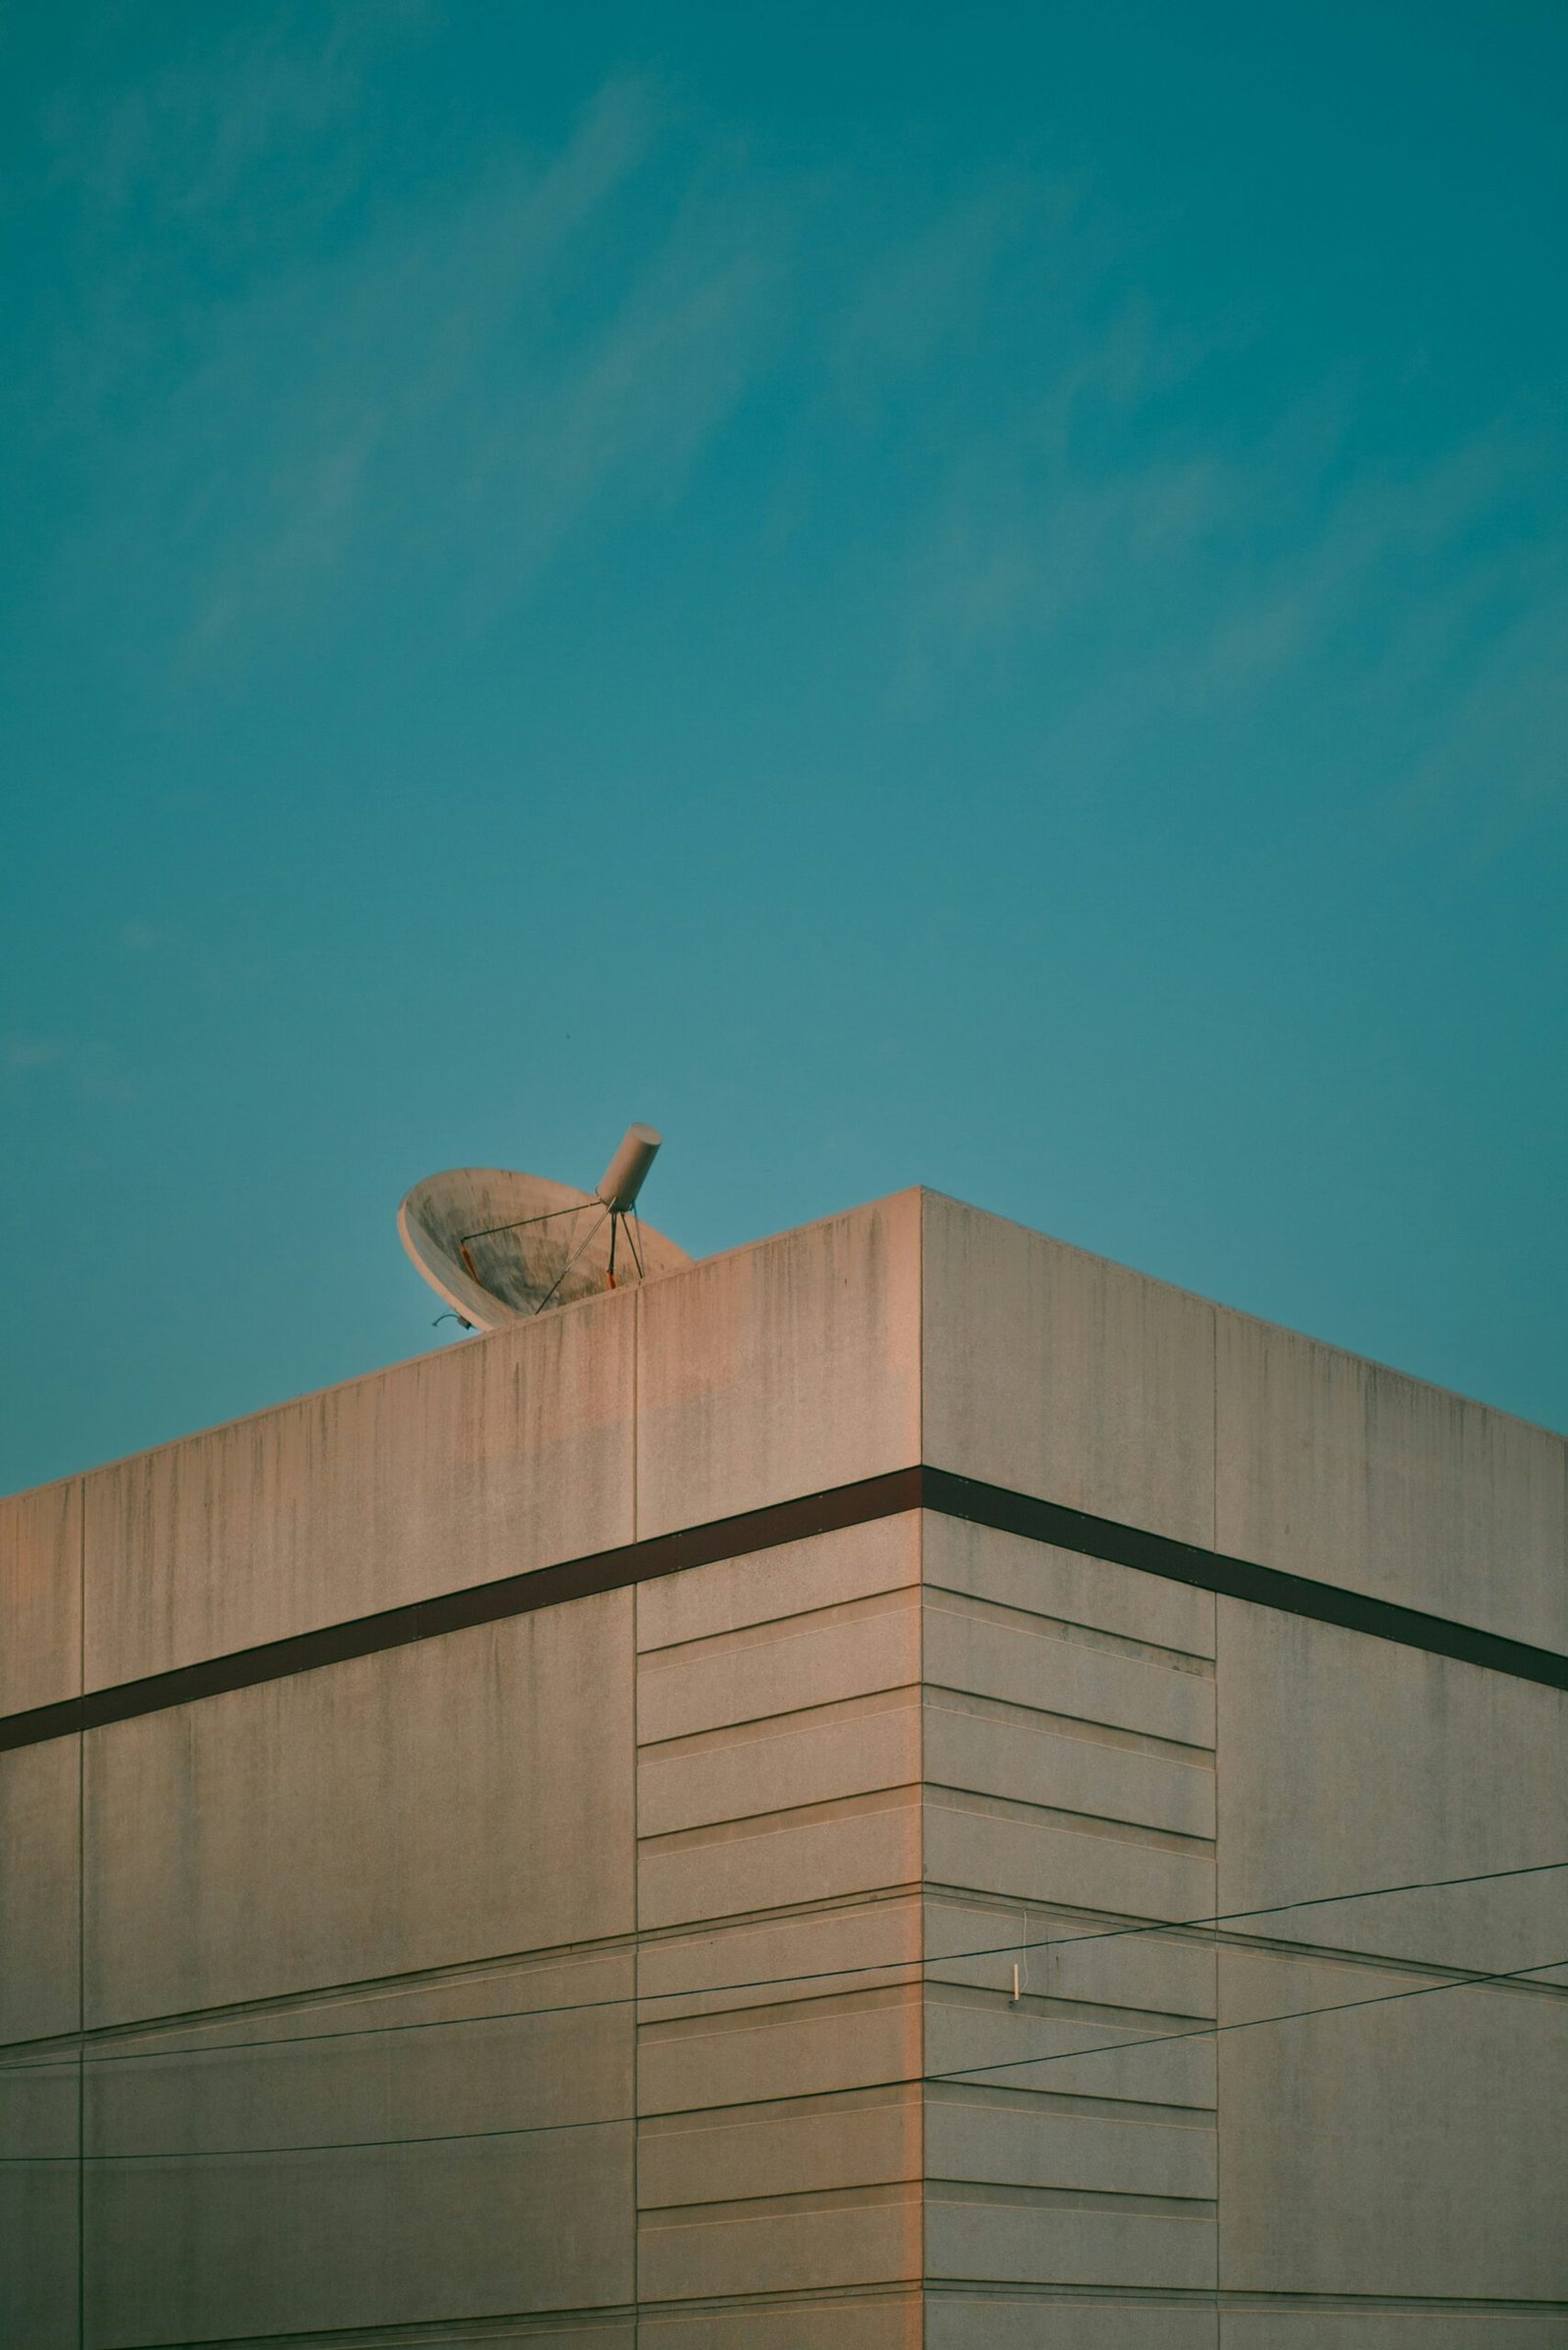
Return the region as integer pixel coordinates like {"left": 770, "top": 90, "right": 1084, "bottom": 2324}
{"left": 901, "top": 292, "right": 1568, "bottom": 864}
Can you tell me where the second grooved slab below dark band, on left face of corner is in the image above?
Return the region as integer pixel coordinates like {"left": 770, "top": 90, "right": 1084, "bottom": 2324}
{"left": 637, "top": 1589, "right": 921, "bottom": 1746}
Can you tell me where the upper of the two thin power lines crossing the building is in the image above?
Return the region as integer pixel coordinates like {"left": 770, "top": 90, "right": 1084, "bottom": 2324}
{"left": 0, "top": 1861, "right": 1568, "bottom": 2073}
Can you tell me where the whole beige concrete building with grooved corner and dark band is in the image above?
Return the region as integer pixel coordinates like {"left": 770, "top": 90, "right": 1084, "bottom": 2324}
{"left": 0, "top": 1192, "right": 1568, "bottom": 2350}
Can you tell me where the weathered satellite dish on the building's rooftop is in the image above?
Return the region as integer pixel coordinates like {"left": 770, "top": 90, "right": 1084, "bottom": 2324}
{"left": 397, "top": 1126, "right": 691, "bottom": 1330}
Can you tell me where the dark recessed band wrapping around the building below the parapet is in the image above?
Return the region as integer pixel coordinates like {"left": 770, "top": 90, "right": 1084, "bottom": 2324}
{"left": 0, "top": 1466, "right": 1568, "bottom": 1753}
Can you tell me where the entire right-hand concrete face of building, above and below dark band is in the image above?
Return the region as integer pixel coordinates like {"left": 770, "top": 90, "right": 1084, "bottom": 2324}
{"left": 921, "top": 1199, "right": 1568, "bottom": 2350}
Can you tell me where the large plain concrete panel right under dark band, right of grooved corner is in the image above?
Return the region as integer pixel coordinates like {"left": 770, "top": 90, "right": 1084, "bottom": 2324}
{"left": 1218, "top": 1600, "right": 1568, "bottom": 1970}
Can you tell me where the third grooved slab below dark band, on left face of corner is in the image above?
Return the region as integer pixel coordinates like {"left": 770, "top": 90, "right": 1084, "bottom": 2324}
{"left": 637, "top": 1689, "right": 926, "bottom": 1837}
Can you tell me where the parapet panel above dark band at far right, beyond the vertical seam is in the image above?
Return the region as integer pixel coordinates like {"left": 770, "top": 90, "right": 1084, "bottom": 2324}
{"left": 1215, "top": 1313, "right": 1568, "bottom": 1649}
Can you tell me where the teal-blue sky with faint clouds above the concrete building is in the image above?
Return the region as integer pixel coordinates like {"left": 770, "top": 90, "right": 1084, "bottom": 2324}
{"left": 0, "top": 0, "right": 1568, "bottom": 1488}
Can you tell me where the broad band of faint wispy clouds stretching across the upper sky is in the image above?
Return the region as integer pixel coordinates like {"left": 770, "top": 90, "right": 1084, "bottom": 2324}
{"left": 24, "top": 5, "right": 1568, "bottom": 874}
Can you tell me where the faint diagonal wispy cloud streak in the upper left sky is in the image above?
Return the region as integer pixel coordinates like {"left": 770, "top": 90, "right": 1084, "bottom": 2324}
{"left": 44, "top": 62, "right": 790, "bottom": 674}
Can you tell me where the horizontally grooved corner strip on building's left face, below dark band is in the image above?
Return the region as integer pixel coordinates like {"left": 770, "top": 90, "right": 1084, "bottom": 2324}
{"left": 637, "top": 1513, "right": 921, "bottom": 2350}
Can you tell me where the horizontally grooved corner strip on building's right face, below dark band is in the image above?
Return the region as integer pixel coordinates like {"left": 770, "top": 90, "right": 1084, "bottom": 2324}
{"left": 924, "top": 1516, "right": 1218, "bottom": 2345}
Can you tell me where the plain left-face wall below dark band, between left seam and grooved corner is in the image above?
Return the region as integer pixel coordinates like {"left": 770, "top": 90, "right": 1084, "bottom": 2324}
{"left": 82, "top": 1591, "right": 635, "bottom": 2350}
